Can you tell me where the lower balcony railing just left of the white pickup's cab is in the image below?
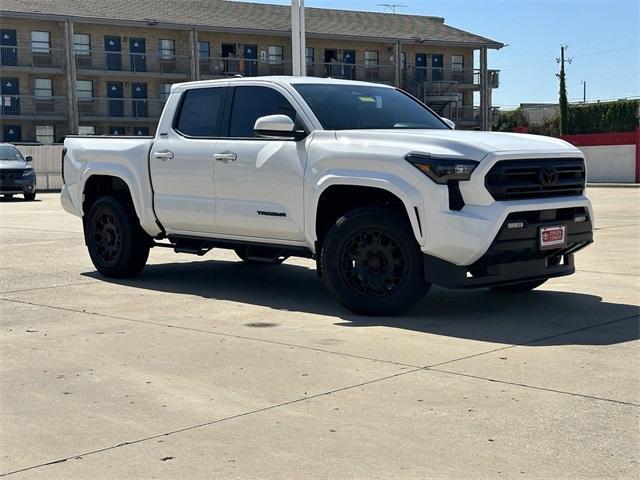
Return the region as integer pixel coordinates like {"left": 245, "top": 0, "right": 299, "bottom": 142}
{"left": 78, "top": 97, "right": 165, "bottom": 121}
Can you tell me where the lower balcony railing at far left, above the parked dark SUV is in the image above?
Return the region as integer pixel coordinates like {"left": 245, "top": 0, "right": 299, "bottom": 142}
{"left": 0, "top": 95, "right": 68, "bottom": 121}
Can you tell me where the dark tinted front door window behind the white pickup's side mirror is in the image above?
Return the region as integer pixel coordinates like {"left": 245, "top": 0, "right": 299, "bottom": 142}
{"left": 229, "top": 87, "right": 296, "bottom": 137}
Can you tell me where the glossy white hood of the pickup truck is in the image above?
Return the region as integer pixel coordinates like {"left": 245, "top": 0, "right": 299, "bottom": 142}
{"left": 336, "top": 129, "right": 582, "bottom": 160}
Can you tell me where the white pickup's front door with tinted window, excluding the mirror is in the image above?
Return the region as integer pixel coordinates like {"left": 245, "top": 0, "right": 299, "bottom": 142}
{"left": 215, "top": 85, "right": 306, "bottom": 241}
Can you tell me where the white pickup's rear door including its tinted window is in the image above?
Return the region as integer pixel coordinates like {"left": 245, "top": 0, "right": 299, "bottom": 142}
{"left": 150, "top": 83, "right": 227, "bottom": 233}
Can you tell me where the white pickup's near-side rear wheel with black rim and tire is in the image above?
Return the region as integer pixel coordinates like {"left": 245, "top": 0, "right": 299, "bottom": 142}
{"left": 85, "top": 196, "right": 151, "bottom": 278}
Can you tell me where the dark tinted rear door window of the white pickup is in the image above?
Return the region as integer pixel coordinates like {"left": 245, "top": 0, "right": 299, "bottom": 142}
{"left": 176, "top": 87, "right": 226, "bottom": 137}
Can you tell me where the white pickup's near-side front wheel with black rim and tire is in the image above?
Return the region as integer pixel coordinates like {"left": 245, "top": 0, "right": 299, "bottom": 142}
{"left": 320, "top": 207, "right": 431, "bottom": 316}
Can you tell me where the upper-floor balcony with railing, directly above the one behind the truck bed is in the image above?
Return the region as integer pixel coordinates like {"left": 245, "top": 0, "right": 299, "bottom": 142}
{"left": 75, "top": 49, "right": 191, "bottom": 79}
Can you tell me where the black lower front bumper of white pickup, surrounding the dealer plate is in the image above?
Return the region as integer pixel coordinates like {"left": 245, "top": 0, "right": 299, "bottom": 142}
{"left": 424, "top": 207, "right": 593, "bottom": 288}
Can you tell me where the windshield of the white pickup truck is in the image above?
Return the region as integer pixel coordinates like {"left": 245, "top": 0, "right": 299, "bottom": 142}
{"left": 293, "top": 83, "right": 448, "bottom": 130}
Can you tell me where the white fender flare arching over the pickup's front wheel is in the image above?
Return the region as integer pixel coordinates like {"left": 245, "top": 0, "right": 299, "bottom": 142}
{"left": 305, "top": 170, "right": 425, "bottom": 250}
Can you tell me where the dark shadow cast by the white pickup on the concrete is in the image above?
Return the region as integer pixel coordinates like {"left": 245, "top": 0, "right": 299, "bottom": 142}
{"left": 83, "top": 260, "right": 640, "bottom": 346}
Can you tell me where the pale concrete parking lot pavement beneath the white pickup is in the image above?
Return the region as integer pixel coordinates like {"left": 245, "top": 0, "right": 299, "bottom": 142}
{"left": 0, "top": 188, "right": 640, "bottom": 479}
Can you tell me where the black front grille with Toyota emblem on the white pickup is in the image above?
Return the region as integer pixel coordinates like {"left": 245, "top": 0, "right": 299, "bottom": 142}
{"left": 485, "top": 158, "right": 586, "bottom": 200}
